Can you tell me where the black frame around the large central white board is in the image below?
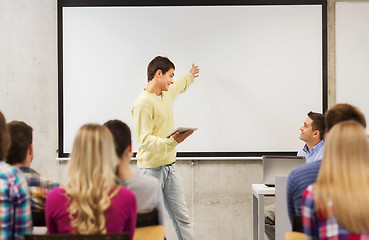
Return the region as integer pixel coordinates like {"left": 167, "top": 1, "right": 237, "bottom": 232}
{"left": 58, "top": 1, "right": 327, "bottom": 157}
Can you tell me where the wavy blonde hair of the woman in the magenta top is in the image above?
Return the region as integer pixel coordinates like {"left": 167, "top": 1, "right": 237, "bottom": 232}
{"left": 65, "top": 124, "right": 119, "bottom": 234}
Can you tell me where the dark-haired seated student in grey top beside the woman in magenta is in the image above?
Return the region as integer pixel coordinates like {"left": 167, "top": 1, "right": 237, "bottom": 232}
{"left": 104, "top": 120, "right": 164, "bottom": 225}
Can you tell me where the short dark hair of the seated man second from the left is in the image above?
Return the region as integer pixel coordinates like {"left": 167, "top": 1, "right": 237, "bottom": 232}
{"left": 6, "top": 121, "right": 33, "bottom": 165}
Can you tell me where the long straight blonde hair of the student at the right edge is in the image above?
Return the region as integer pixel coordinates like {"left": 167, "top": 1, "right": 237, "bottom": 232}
{"left": 314, "top": 121, "right": 369, "bottom": 234}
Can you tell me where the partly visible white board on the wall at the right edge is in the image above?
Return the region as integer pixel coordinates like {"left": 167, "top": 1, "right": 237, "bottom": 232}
{"left": 336, "top": 2, "right": 369, "bottom": 134}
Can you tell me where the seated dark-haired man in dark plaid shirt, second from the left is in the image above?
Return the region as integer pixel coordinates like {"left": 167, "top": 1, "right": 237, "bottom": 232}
{"left": 7, "top": 121, "right": 59, "bottom": 210}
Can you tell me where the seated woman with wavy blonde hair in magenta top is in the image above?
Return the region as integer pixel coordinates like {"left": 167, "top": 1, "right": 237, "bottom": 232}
{"left": 45, "top": 124, "right": 137, "bottom": 239}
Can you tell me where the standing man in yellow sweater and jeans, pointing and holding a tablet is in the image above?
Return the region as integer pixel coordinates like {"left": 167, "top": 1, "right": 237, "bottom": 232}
{"left": 131, "top": 56, "right": 199, "bottom": 240}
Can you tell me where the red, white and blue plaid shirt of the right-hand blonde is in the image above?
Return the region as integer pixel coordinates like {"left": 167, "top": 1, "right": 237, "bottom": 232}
{"left": 301, "top": 185, "right": 369, "bottom": 240}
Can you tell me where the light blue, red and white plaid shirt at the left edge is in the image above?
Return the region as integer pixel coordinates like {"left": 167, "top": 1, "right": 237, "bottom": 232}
{"left": 0, "top": 162, "right": 32, "bottom": 240}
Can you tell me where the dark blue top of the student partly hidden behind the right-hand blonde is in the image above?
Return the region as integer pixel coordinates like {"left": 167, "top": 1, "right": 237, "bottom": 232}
{"left": 287, "top": 160, "right": 322, "bottom": 224}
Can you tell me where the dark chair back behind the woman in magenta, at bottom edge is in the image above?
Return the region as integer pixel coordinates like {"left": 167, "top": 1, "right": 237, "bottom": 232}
{"left": 25, "top": 233, "right": 130, "bottom": 240}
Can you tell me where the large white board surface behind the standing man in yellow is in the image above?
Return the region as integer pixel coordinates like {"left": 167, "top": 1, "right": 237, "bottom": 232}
{"left": 59, "top": 1, "right": 323, "bottom": 156}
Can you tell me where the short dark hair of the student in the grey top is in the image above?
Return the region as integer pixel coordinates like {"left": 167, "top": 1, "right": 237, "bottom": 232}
{"left": 104, "top": 120, "right": 132, "bottom": 157}
